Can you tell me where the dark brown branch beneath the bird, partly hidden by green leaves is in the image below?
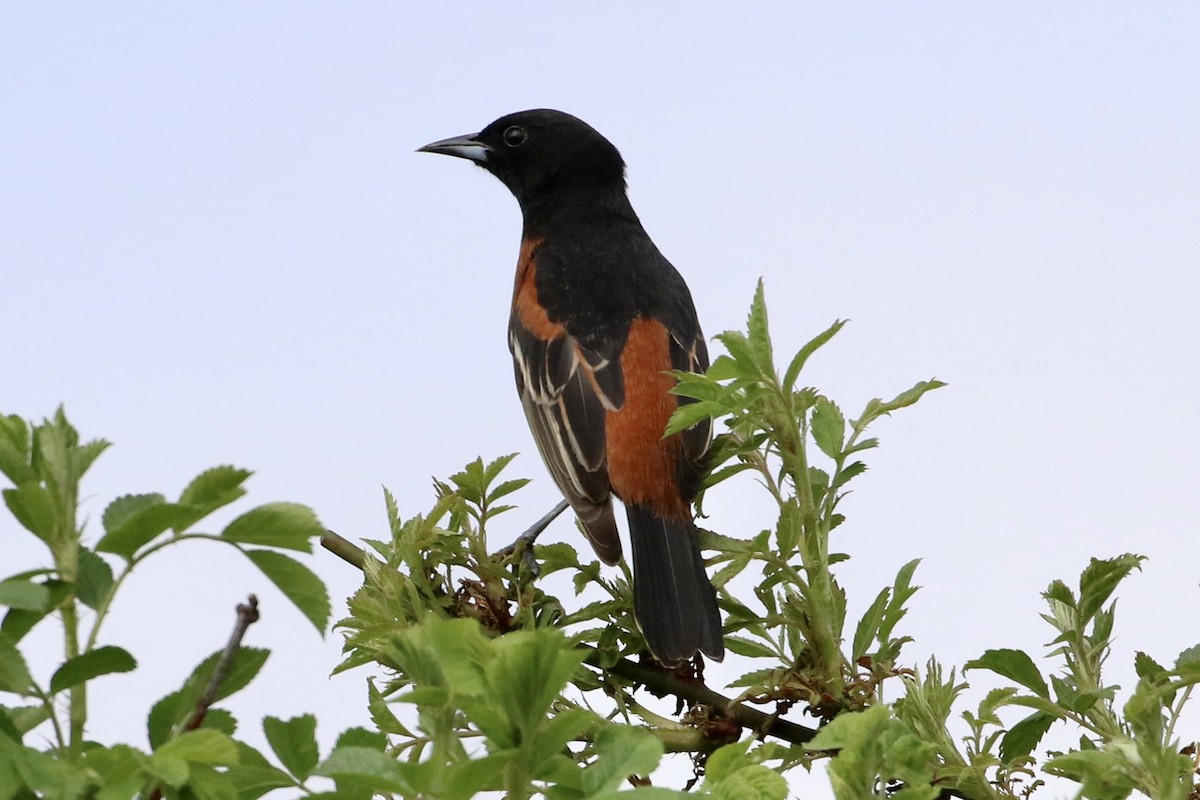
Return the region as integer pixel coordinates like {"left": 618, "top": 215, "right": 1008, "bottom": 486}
{"left": 320, "top": 527, "right": 817, "bottom": 745}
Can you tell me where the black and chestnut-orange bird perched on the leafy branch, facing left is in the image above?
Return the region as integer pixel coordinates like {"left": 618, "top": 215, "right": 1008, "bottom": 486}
{"left": 419, "top": 109, "right": 725, "bottom": 667}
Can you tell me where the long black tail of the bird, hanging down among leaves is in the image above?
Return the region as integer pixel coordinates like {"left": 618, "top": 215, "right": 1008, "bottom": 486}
{"left": 625, "top": 504, "right": 725, "bottom": 667}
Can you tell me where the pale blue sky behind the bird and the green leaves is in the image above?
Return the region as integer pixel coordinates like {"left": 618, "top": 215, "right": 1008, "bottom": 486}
{"left": 0, "top": 2, "right": 1200, "bottom": 796}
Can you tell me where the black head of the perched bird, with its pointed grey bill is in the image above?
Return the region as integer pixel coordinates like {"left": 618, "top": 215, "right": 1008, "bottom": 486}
{"left": 419, "top": 108, "right": 625, "bottom": 210}
